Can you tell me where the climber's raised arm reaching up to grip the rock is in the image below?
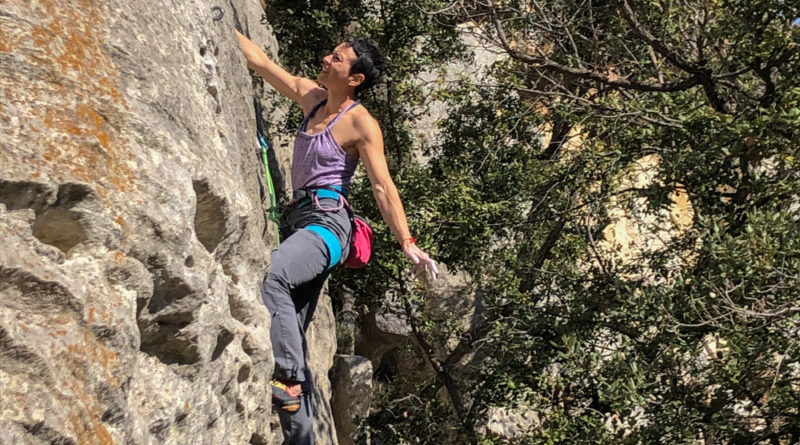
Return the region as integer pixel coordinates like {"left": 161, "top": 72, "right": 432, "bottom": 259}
{"left": 236, "top": 31, "right": 324, "bottom": 109}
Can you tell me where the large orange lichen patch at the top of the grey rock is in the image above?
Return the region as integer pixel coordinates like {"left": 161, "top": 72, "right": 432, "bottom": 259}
{"left": 9, "top": 0, "right": 136, "bottom": 200}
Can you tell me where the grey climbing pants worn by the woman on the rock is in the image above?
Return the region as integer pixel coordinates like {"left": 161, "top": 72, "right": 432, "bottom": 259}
{"left": 261, "top": 197, "right": 352, "bottom": 445}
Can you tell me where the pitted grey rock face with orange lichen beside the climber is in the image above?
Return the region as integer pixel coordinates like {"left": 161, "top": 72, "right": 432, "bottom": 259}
{"left": 0, "top": 0, "right": 335, "bottom": 444}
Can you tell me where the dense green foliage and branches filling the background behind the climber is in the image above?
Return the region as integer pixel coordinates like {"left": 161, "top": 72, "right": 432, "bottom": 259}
{"left": 269, "top": 0, "right": 800, "bottom": 444}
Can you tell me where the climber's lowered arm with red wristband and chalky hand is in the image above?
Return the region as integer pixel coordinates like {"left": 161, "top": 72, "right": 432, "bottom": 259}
{"left": 355, "top": 116, "right": 439, "bottom": 280}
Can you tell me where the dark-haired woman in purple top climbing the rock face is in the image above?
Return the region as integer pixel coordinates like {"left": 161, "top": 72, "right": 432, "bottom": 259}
{"left": 237, "top": 31, "right": 438, "bottom": 444}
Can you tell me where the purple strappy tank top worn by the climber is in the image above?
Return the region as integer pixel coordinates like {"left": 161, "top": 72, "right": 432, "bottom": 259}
{"left": 292, "top": 100, "right": 358, "bottom": 190}
